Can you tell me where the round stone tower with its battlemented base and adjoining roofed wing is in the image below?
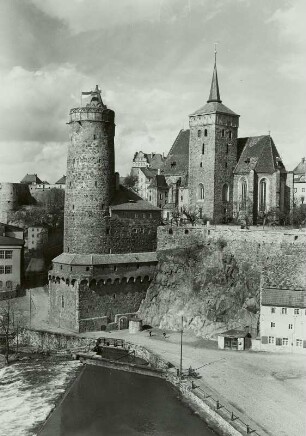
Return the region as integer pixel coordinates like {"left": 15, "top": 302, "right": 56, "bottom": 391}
{"left": 49, "top": 87, "right": 161, "bottom": 331}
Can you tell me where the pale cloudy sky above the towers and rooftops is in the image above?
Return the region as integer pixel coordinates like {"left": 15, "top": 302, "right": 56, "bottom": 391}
{"left": 0, "top": 0, "right": 306, "bottom": 182}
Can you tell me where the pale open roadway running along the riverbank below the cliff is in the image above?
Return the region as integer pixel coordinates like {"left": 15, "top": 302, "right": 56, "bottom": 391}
{"left": 80, "top": 330, "right": 306, "bottom": 436}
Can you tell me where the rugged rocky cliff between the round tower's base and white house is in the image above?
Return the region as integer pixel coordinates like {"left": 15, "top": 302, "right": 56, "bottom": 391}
{"left": 139, "top": 232, "right": 292, "bottom": 337}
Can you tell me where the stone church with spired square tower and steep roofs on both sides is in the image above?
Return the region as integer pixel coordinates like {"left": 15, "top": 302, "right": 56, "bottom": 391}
{"left": 161, "top": 53, "right": 293, "bottom": 224}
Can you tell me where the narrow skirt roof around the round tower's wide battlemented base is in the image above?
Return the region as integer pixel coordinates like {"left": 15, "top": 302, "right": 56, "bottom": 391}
{"left": 53, "top": 251, "right": 157, "bottom": 265}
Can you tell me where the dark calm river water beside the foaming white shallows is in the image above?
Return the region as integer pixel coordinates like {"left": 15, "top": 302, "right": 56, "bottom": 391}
{"left": 39, "top": 365, "right": 215, "bottom": 436}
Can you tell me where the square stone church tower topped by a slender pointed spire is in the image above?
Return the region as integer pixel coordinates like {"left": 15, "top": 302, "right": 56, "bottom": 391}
{"left": 189, "top": 53, "right": 239, "bottom": 222}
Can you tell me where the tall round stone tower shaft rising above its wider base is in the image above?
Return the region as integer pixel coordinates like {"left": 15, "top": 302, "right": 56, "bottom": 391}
{"left": 64, "top": 86, "right": 115, "bottom": 254}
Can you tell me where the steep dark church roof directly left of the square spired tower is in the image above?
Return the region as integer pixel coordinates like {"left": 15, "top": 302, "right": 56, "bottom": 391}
{"left": 161, "top": 129, "right": 190, "bottom": 176}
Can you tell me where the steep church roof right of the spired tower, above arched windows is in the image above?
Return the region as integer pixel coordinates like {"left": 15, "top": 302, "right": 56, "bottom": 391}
{"left": 234, "top": 135, "right": 286, "bottom": 174}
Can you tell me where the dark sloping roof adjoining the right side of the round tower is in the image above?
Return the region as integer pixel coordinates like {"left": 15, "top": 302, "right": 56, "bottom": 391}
{"left": 110, "top": 185, "right": 160, "bottom": 211}
